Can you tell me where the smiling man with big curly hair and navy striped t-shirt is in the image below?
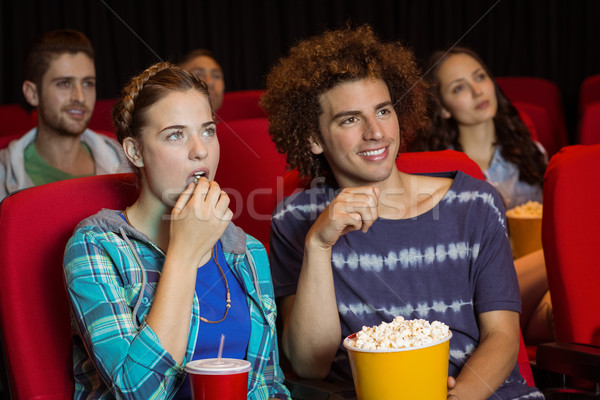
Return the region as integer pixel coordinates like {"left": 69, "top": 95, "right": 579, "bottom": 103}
{"left": 262, "top": 26, "right": 543, "bottom": 400}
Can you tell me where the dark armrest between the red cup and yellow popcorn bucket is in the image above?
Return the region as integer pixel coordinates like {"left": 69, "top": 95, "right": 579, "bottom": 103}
{"left": 285, "top": 376, "right": 356, "bottom": 400}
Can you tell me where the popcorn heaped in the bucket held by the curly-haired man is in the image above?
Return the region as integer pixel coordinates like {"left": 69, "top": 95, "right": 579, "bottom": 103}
{"left": 348, "top": 316, "right": 450, "bottom": 350}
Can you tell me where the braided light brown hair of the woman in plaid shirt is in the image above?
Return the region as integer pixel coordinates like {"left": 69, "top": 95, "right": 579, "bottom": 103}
{"left": 113, "top": 62, "right": 212, "bottom": 143}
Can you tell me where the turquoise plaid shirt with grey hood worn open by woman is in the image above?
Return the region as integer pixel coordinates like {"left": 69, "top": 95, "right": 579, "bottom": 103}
{"left": 64, "top": 210, "right": 290, "bottom": 400}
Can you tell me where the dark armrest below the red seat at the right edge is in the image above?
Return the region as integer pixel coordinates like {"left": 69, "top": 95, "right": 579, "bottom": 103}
{"left": 536, "top": 342, "right": 600, "bottom": 382}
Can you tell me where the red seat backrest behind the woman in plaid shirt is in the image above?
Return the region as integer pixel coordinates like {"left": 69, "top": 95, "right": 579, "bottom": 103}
{"left": 0, "top": 174, "right": 137, "bottom": 400}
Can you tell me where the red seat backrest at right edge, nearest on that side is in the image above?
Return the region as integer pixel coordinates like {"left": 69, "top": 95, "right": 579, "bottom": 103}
{"left": 542, "top": 145, "right": 600, "bottom": 345}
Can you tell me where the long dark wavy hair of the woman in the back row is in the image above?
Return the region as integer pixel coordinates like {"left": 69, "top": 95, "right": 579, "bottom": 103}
{"left": 411, "top": 47, "right": 546, "bottom": 186}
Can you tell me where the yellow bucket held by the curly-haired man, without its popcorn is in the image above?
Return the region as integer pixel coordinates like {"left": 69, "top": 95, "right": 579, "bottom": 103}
{"left": 344, "top": 333, "right": 452, "bottom": 400}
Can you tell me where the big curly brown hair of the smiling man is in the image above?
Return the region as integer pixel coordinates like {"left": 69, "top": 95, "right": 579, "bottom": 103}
{"left": 260, "top": 25, "right": 428, "bottom": 178}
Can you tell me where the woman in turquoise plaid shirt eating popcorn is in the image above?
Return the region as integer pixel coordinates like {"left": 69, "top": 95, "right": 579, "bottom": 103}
{"left": 64, "top": 63, "right": 289, "bottom": 400}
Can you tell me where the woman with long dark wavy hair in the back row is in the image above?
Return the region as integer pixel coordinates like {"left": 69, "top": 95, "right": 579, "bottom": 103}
{"left": 411, "top": 47, "right": 554, "bottom": 344}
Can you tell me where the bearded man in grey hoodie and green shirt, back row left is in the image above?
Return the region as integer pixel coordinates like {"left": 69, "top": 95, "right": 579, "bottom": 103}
{"left": 0, "top": 29, "right": 130, "bottom": 200}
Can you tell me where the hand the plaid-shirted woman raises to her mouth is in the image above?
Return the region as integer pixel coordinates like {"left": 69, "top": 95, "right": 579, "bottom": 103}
{"left": 168, "top": 178, "right": 233, "bottom": 267}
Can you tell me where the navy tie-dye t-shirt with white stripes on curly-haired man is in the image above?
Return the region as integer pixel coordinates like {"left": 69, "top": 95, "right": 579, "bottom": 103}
{"left": 269, "top": 172, "right": 543, "bottom": 399}
